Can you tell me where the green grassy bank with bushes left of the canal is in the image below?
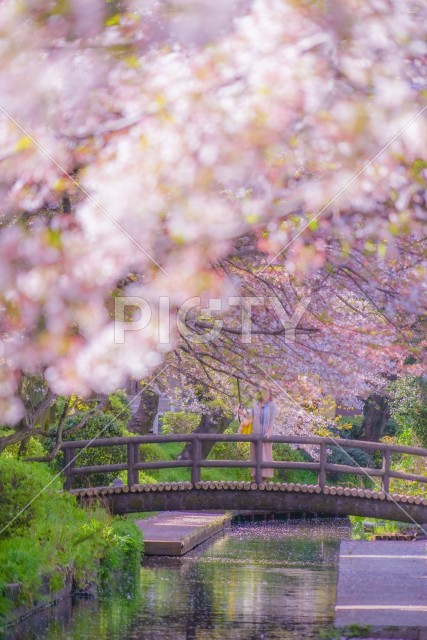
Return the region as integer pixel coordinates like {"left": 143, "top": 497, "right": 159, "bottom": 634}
{"left": 0, "top": 458, "right": 143, "bottom": 626}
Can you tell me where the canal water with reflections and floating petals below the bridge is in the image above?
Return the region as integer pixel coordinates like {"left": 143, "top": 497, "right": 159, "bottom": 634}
{"left": 10, "top": 520, "right": 351, "bottom": 640}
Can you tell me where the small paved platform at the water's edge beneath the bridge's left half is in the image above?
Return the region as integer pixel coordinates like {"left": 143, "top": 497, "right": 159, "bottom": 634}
{"left": 136, "top": 511, "right": 231, "bottom": 556}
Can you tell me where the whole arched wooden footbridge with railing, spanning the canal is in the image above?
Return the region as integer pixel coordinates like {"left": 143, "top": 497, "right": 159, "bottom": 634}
{"left": 62, "top": 432, "right": 427, "bottom": 524}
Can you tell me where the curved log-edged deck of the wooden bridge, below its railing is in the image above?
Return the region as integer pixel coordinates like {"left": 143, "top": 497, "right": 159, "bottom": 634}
{"left": 72, "top": 482, "right": 427, "bottom": 524}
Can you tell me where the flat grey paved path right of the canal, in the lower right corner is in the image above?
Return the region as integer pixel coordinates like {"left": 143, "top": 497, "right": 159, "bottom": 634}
{"left": 335, "top": 540, "right": 427, "bottom": 637}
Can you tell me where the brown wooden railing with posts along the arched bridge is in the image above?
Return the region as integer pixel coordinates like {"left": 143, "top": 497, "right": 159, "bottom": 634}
{"left": 62, "top": 432, "right": 427, "bottom": 493}
